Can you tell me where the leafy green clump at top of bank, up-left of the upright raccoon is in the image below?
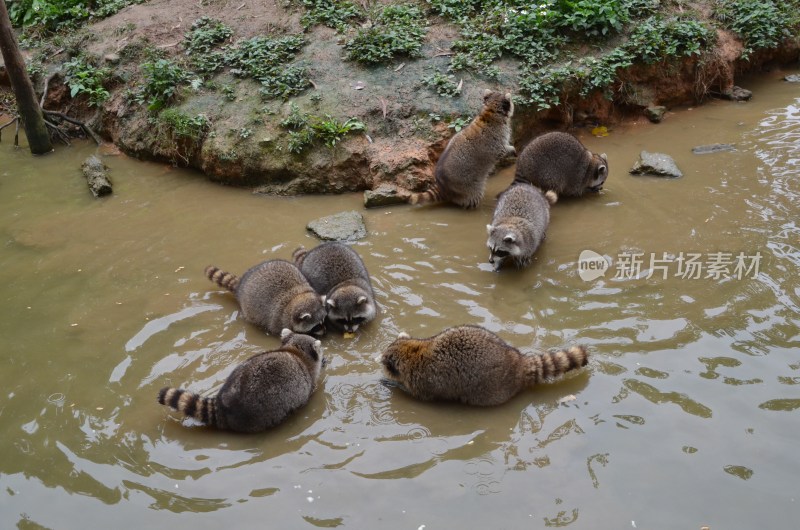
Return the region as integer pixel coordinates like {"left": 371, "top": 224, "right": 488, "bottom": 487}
{"left": 344, "top": 5, "right": 426, "bottom": 64}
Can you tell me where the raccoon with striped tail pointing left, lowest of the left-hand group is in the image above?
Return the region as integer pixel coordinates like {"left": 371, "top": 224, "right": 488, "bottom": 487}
{"left": 158, "top": 329, "right": 324, "bottom": 433}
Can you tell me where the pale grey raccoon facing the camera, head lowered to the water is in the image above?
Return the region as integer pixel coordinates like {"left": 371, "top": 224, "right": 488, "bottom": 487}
{"left": 486, "top": 182, "right": 558, "bottom": 271}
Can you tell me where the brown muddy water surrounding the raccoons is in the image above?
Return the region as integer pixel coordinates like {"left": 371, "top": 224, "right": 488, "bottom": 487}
{"left": 0, "top": 72, "right": 800, "bottom": 530}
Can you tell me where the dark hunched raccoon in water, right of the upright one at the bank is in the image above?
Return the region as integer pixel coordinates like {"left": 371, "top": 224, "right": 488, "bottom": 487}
{"left": 514, "top": 132, "right": 608, "bottom": 197}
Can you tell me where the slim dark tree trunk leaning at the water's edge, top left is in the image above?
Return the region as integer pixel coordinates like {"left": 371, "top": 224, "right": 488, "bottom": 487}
{"left": 0, "top": 0, "right": 53, "bottom": 155}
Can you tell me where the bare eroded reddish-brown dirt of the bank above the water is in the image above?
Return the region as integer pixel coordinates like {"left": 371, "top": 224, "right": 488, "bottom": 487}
{"left": 0, "top": 0, "right": 800, "bottom": 194}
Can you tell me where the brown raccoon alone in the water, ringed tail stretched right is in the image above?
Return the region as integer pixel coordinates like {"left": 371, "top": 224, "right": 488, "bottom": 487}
{"left": 378, "top": 326, "right": 589, "bottom": 406}
